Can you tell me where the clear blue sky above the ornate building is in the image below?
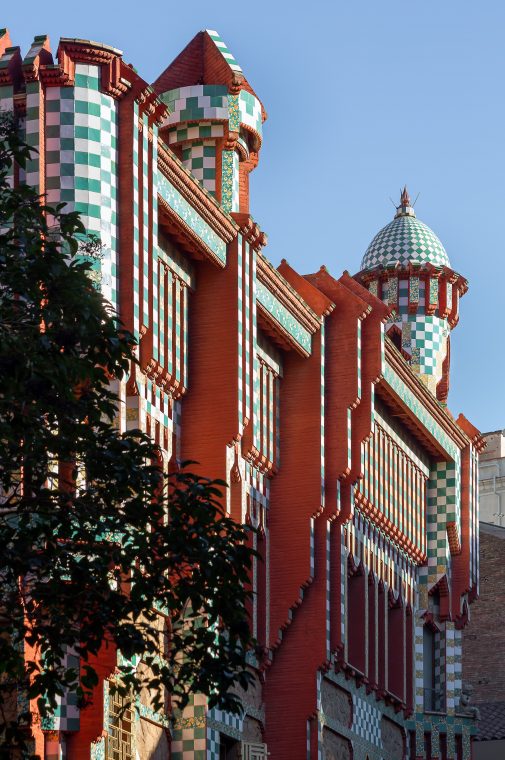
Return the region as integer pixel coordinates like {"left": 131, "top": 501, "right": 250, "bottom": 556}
{"left": 0, "top": 0, "right": 505, "bottom": 431}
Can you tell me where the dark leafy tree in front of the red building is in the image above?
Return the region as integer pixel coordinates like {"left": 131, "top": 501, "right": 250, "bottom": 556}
{"left": 0, "top": 119, "right": 253, "bottom": 746}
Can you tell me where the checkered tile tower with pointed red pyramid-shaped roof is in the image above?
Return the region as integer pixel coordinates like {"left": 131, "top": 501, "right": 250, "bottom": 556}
{"left": 153, "top": 29, "right": 266, "bottom": 214}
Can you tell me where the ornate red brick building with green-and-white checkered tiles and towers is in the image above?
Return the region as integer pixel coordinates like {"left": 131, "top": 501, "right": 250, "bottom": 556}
{"left": 0, "top": 25, "right": 481, "bottom": 760}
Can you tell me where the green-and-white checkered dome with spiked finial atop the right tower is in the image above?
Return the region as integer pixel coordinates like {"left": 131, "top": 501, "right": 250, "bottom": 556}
{"left": 361, "top": 188, "right": 450, "bottom": 269}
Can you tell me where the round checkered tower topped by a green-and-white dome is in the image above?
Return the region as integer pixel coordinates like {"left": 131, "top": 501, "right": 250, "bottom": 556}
{"left": 358, "top": 187, "right": 468, "bottom": 403}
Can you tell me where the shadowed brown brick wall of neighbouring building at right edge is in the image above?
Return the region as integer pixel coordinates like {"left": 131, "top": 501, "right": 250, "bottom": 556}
{"left": 463, "top": 523, "right": 505, "bottom": 703}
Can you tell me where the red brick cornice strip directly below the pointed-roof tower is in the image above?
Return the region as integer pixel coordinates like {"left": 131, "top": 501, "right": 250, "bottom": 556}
{"left": 158, "top": 141, "right": 238, "bottom": 243}
